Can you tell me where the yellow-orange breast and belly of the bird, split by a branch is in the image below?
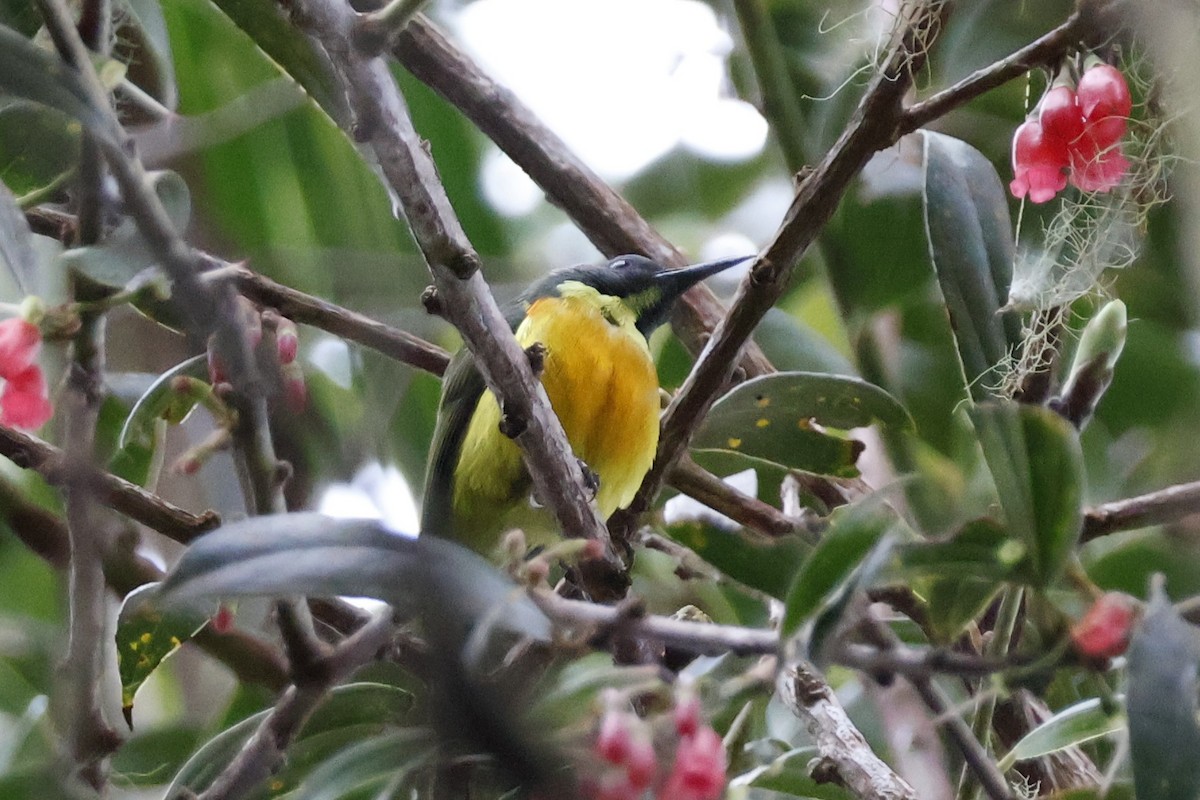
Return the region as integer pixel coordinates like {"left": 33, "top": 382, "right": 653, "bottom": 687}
{"left": 454, "top": 296, "right": 659, "bottom": 542}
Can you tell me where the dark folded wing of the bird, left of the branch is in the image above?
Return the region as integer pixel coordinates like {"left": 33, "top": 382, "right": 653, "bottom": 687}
{"left": 421, "top": 348, "right": 487, "bottom": 537}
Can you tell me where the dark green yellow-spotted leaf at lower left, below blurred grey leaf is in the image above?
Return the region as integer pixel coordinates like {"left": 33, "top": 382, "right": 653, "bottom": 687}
{"left": 116, "top": 583, "right": 215, "bottom": 728}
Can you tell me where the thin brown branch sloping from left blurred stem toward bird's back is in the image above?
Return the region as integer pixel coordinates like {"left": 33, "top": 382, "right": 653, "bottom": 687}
{"left": 220, "top": 264, "right": 450, "bottom": 375}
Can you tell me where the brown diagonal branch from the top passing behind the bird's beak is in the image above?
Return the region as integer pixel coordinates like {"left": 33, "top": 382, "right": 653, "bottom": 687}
{"left": 394, "top": 16, "right": 774, "bottom": 377}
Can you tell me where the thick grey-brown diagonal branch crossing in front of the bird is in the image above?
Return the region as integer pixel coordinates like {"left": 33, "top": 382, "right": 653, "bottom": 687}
{"left": 295, "top": 0, "right": 624, "bottom": 595}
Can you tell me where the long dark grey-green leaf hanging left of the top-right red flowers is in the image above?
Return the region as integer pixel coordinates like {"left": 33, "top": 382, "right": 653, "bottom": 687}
{"left": 922, "top": 131, "right": 1020, "bottom": 401}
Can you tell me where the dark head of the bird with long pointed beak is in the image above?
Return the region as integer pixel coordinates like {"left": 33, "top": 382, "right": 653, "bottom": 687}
{"left": 527, "top": 255, "right": 752, "bottom": 337}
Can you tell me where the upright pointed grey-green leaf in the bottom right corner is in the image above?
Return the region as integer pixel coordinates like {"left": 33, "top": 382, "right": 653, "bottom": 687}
{"left": 1126, "top": 581, "right": 1200, "bottom": 800}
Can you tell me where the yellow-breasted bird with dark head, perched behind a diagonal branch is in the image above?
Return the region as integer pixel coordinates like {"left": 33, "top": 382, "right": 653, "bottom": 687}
{"left": 421, "top": 255, "right": 746, "bottom": 552}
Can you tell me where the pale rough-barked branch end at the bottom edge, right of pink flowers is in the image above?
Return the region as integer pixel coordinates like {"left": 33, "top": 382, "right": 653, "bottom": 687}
{"left": 776, "top": 663, "right": 917, "bottom": 800}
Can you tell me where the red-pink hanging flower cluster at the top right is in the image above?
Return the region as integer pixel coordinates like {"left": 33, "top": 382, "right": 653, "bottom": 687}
{"left": 1008, "top": 64, "right": 1133, "bottom": 203}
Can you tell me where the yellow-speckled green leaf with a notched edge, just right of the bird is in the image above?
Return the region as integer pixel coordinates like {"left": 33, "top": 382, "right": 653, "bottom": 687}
{"left": 692, "top": 372, "right": 912, "bottom": 477}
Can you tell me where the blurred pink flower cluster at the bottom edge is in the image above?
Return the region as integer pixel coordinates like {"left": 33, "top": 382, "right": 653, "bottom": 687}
{"left": 584, "top": 691, "right": 728, "bottom": 800}
